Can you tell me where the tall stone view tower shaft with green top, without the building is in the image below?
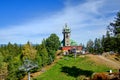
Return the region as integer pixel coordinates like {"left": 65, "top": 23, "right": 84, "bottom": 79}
{"left": 62, "top": 24, "right": 71, "bottom": 46}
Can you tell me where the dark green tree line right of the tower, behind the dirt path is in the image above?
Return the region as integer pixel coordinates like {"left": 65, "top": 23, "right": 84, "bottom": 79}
{"left": 86, "top": 12, "right": 120, "bottom": 54}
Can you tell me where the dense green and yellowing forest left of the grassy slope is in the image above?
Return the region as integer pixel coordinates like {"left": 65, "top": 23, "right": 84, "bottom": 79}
{"left": 0, "top": 33, "right": 60, "bottom": 80}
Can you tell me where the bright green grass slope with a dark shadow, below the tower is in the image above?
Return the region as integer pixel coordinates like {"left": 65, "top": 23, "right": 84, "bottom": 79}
{"left": 34, "top": 57, "right": 114, "bottom": 80}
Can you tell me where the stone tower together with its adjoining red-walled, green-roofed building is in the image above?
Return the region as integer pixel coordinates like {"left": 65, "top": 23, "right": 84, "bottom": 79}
{"left": 61, "top": 24, "right": 82, "bottom": 51}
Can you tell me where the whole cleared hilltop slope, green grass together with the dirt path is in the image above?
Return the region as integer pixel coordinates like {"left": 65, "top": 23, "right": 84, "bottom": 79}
{"left": 25, "top": 54, "right": 120, "bottom": 80}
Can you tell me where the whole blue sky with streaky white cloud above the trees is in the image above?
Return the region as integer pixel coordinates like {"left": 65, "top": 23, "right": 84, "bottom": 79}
{"left": 0, "top": 0, "right": 120, "bottom": 44}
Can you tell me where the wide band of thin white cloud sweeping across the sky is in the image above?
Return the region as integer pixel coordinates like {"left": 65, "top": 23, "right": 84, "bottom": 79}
{"left": 0, "top": 0, "right": 120, "bottom": 44}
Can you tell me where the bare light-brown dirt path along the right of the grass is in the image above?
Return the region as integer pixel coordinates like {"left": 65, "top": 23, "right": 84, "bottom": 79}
{"left": 87, "top": 54, "right": 120, "bottom": 69}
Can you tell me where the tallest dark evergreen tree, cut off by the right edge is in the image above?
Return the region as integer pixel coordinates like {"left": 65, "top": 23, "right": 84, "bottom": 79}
{"left": 105, "top": 11, "right": 120, "bottom": 53}
